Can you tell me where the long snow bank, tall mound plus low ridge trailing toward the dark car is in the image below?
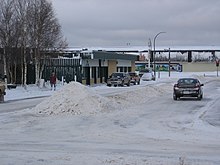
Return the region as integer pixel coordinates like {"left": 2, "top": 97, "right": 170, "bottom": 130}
{"left": 33, "top": 82, "right": 172, "bottom": 115}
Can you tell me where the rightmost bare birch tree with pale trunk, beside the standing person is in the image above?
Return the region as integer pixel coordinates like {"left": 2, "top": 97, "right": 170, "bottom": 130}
{"left": 29, "top": 0, "right": 65, "bottom": 85}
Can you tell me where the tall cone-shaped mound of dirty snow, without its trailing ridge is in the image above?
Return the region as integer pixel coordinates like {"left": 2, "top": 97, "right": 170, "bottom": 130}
{"left": 34, "top": 82, "right": 117, "bottom": 115}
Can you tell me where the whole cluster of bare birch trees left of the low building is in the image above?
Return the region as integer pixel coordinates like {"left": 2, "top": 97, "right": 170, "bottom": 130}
{"left": 0, "top": 0, "right": 67, "bottom": 86}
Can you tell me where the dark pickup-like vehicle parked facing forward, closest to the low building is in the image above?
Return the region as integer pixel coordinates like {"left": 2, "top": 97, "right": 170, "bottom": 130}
{"left": 107, "top": 72, "right": 130, "bottom": 86}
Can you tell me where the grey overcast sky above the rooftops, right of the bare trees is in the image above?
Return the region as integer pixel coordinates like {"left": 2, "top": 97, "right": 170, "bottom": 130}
{"left": 51, "top": 0, "right": 220, "bottom": 47}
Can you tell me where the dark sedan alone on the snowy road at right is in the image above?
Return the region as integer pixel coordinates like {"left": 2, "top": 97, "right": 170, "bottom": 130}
{"left": 173, "top": 78, "right": 204, "bottom": 100}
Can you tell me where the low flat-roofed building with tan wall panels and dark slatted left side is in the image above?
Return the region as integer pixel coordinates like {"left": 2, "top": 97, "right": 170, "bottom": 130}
{"left": 42, "top": 49, "right": 139, "bottom": 85}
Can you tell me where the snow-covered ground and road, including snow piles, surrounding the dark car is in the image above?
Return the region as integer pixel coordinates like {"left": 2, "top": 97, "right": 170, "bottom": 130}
{"left": 0, "top": 72, "right": 220, "bottom": 165}
